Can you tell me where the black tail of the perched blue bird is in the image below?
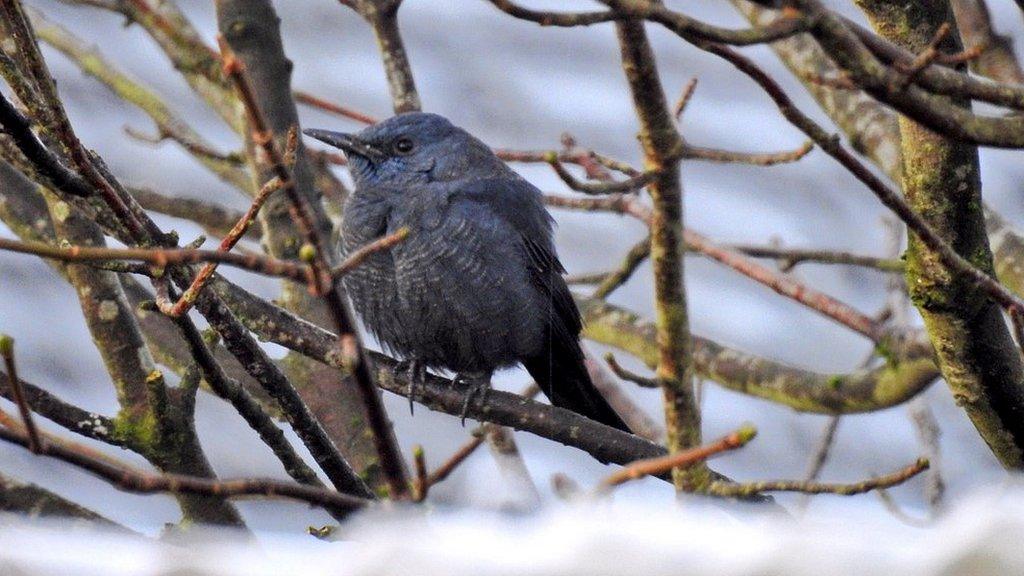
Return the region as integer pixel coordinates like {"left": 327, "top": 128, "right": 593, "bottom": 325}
{"left": 522, "top": 336, "right": 632, "bottom": 433}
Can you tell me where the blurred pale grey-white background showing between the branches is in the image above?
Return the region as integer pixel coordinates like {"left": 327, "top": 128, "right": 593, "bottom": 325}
{"left": 0, "top": 0, "right": 1024, "bottom": 533}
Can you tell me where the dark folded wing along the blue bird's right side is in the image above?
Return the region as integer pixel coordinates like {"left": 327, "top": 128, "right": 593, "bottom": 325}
{"left": 451, "top": 178, "right": 583, "bottom": 338}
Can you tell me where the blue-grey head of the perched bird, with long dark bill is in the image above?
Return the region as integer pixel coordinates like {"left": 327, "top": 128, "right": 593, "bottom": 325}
{"left": 303, "top": 112, "right": 506, "bottom": 187}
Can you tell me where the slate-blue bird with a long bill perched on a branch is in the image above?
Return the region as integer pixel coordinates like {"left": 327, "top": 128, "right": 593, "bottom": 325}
{"left": 305, "top": 113, "right": 629, "bottom": 431}
